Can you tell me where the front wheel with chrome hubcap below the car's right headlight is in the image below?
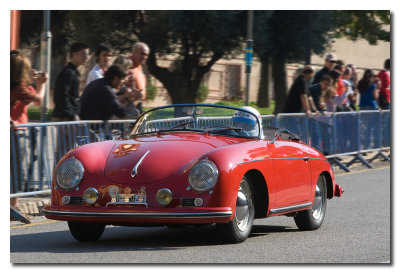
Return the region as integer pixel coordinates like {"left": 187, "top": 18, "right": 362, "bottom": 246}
{"left": 217, "top": 177, "right": 254, "bottom": 243}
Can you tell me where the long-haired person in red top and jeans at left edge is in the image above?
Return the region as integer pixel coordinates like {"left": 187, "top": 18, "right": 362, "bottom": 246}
{"left": 10, "top": 50, "right": 48, "bottom": 210}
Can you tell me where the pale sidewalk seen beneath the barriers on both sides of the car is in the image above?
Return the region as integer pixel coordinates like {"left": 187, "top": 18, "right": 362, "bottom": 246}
{"left": 12, "top": 151, "right": 390, "bottom": 216}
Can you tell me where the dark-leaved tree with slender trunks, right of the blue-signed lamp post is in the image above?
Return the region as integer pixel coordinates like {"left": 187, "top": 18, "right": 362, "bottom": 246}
{"left": 254, "top": 11, "right": 390, "bottom": 112}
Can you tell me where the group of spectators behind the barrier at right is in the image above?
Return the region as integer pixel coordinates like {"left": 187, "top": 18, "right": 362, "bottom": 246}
{"left": 282, "top": 53, "right": 390, "bottom": 115}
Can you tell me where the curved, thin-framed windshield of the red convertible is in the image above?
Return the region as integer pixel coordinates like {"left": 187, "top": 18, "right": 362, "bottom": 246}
{"left": 129, "top": 104, "right": 260, "bottom": 138}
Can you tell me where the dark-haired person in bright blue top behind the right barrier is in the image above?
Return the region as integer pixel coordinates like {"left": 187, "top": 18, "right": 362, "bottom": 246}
{"left": 357, "top": 69, "right": 378, "bottom": 110}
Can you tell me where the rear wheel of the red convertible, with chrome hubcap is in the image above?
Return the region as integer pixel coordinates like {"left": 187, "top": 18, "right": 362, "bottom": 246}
{"left": 294, "top": 176, "right": 327, "bottom": 230}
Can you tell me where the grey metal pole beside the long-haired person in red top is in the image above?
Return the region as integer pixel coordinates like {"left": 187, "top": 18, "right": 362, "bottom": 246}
{"left": 40, "top": 10, "right": 52, "bottom": 122}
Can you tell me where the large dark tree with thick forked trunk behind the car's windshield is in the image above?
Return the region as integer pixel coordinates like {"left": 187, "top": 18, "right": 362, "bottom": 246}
{"left": 70, "top": 11, "right": 246, "bottom": 103}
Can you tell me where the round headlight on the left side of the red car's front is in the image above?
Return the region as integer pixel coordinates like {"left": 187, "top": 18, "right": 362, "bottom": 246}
{"left": 55, "top": 157, "right": 85, "bottom": 191}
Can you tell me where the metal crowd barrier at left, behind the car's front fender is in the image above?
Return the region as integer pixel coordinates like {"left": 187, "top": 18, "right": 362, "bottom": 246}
{"left": 10, "top": 120, "right": 135, "bottom": 197}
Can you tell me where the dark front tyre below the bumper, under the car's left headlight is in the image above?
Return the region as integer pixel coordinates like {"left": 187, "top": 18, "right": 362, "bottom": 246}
{"left": 68, "top": 222, "right": 105, "bottom": 242}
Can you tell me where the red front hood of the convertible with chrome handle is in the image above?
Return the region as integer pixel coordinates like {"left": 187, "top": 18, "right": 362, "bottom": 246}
{"left": 105, "top": 133, "right": 248, "bottom": 184}
